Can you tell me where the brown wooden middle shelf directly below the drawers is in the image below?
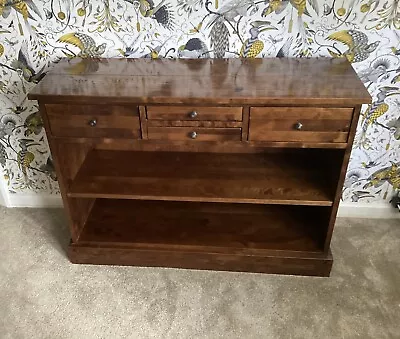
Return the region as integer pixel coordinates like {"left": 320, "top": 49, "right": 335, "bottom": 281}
{"left": 67, "top": 149, "right": 339, "bottom": 206}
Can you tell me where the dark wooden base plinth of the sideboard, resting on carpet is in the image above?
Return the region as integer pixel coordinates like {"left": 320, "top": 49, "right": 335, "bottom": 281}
{"left": 68, "top": 243, "right": 333, "bottom": 277}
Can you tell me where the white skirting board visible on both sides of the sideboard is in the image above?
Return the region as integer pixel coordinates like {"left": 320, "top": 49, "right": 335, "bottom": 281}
{"left": 0, "top": 194, "right": 400, "bottom": 219}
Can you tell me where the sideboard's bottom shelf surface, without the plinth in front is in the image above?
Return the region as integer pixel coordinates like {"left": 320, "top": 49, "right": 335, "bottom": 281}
{"left": 77, "top": 199, "right": 330, "bottom": 255}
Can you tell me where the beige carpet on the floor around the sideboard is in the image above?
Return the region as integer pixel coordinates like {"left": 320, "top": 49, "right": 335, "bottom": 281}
{"left": 0, "top": 208, "right": 400, "bottom": 339}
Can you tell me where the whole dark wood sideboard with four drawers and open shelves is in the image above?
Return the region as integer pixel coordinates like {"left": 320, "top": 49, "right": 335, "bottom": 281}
{"left": 29, "top": 59, "right": 371, "bottom": 276}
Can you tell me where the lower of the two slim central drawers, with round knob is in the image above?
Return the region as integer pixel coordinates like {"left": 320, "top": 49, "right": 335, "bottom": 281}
{"left": 147, "top": 127, "right": 242, "bottom": 141}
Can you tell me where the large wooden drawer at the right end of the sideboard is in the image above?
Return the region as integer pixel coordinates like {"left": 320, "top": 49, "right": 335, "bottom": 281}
{"left": 249, "top": 107, "right": 353, "bottom": 143}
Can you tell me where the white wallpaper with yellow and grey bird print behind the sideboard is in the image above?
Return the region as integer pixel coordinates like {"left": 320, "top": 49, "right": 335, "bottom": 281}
{"left": 0, "top": 0, "right": 400, "bottom": 202}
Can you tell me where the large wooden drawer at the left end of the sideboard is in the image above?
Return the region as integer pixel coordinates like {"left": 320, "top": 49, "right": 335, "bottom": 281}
{"left": 46, "top": 104, "right": 141, "bottom": 138}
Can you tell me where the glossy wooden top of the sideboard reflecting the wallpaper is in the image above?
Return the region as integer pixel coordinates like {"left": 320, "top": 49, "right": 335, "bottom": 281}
{"left": 29, "top": 58, "right": 371, "bottom": 107}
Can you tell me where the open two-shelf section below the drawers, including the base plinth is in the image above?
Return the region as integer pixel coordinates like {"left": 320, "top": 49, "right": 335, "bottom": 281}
{"left": 67, "top": 148, "right": 343, "bottom": 275}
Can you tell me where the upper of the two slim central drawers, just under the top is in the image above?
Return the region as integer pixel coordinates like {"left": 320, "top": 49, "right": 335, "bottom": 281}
{"left": 147, "top": 106, "right": 242, "bottom": 121}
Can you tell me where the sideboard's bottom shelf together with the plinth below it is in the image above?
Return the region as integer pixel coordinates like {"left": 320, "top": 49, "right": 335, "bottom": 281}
{"left": 69, "top": 199, "right": 332, "bottom": 276}
